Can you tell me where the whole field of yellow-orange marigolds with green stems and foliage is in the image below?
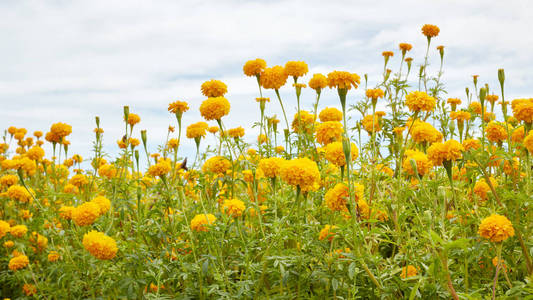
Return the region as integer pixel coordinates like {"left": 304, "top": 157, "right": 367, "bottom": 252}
{"left": 0, "top": 24, "right": 533, "bottom": 299}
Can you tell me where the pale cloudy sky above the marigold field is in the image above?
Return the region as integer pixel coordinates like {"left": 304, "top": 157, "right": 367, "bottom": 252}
{"left": 0, "top": 0, "right": 533, "bottom": 165}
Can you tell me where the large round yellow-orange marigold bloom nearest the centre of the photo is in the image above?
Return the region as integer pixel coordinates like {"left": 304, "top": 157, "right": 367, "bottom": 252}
{"left": 280, "top": 157, "right": 320, "bottom": 192}
